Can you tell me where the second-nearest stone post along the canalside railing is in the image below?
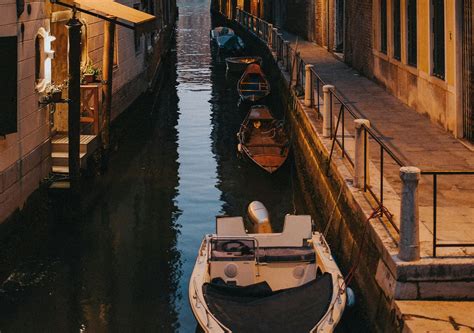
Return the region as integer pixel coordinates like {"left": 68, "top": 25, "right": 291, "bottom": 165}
{"left": 354, "top": 119, "right": 370, "bottom": 189}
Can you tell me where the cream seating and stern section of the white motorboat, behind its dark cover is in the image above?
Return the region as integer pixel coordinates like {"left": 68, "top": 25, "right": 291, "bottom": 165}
{"left": 208, "top": 215, "right": 317, "bottom": 291}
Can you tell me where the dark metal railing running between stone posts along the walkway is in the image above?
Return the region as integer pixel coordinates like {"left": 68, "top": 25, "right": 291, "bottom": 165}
{"left": 231, "top": 8, "right": 474, "bottom": 257}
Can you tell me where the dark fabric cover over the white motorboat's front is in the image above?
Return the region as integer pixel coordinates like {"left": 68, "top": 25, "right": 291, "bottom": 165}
{"left": 203, "top": 273, "right": 333, "bottom": 333}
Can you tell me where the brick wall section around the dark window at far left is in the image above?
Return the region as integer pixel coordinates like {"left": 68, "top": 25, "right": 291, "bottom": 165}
{"left": 0, "top": 0, "right": 51, "bottom": 223}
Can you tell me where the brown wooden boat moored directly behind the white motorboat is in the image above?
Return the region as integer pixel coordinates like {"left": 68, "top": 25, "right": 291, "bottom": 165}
{"left": 237, "top": 105, "right": 290, "bottom": 173}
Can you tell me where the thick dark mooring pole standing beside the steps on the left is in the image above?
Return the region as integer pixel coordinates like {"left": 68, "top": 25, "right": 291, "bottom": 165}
{"left": 66, "top": 10, "right": 82, "bottom": 193}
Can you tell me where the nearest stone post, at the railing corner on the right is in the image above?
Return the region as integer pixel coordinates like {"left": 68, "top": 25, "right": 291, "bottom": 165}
{"left": 398, "top": 167, "right": 421, "bottom": 261}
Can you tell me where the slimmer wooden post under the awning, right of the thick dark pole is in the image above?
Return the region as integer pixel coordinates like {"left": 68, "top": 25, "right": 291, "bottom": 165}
{"left": 102, "top": 17, "right": 115, "bottom": 150}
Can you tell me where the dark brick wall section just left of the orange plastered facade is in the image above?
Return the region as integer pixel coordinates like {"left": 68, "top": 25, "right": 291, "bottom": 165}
{"left": 344, "top": 0, "right": 374, "bottom": 77}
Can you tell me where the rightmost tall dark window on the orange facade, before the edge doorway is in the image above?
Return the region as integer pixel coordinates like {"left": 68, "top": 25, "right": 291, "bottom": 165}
{"left": 431, "top": 0, "right": 445, "bottom": 79}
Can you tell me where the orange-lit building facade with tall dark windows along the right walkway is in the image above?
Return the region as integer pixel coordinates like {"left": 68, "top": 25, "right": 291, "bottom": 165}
{"left": 244, "top": 0, "right": 474, "bottom": 142}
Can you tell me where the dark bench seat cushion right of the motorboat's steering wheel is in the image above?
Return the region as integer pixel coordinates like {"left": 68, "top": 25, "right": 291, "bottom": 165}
{"left": 258, "top": 247, "right": 316, "bottom": 262}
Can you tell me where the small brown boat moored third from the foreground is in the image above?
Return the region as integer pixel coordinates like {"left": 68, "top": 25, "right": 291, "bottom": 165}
{"left": 237, "top": 64, "right": 270, "bottom": 102}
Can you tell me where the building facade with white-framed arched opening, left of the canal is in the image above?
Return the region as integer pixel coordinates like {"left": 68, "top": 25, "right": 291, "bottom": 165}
{"left": 0, "top": 0, "right": 177, "bottom": 223}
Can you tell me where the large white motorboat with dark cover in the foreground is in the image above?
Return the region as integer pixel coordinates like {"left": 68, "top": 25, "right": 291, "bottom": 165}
{"left": 189, "top": 203, "right": 352, "bottom": 333}
